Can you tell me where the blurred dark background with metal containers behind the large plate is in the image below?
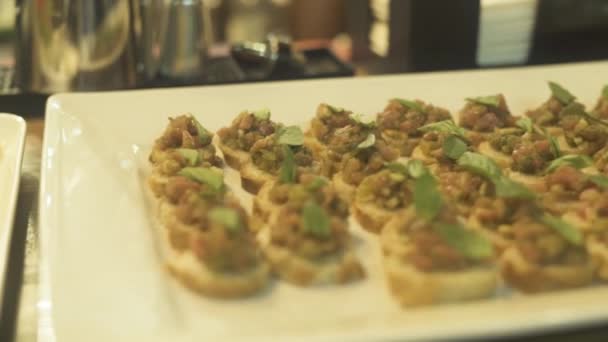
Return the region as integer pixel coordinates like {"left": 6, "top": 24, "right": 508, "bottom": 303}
{"left": 0, "top": 0, "right": 608, "bottom": 111}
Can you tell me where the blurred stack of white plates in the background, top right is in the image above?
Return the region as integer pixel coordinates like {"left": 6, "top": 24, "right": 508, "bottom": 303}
{"left": 477, "top": 0, "right": 537, "bottom": 66}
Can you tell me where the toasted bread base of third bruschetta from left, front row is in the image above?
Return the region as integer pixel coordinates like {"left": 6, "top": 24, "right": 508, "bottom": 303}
{"left": 380, "top": 214, "right": 498, "bottom": 307}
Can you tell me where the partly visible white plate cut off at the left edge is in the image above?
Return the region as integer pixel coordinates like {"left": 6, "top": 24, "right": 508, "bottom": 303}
{"left": 0, "top": 113, "right": 25, "bottom": 306}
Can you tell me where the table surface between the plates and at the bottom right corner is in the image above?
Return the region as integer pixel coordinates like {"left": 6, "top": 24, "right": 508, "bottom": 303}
{"left": 0, "top": 112, "right": 608, "bottom": 342}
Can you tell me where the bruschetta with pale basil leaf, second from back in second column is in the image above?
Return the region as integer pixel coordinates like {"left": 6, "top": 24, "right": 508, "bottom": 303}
{"left": 240, "top": 126, "right": 328, "bottom": 194}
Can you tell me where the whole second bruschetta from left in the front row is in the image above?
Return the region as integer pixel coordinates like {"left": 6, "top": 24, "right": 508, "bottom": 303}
{"left": 261, "top": 185, "right": 365, "bottom": 286}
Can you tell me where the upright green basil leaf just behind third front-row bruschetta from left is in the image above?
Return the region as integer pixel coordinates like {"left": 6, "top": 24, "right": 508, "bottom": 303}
{"left": 414, "top": 172, "right": 442, "bottom": 221}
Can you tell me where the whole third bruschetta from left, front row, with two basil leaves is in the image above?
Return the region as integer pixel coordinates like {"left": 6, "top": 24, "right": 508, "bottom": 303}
{"left": 380, "top": 173, "right": 498, "bottom": 307}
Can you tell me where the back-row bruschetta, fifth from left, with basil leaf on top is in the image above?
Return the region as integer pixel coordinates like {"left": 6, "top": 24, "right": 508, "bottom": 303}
{"left": 458, "top": 94, "right": 516, "bottom": 136}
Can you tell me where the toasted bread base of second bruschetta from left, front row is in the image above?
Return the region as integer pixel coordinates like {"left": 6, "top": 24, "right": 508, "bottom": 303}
{"left": 263, "top": 229, "right": 365, "bottom": 286}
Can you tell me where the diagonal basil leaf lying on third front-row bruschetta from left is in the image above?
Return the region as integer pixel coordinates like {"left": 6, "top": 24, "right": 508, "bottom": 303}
{"left": 433, "top": 223, "right": 494, "bottom": 260}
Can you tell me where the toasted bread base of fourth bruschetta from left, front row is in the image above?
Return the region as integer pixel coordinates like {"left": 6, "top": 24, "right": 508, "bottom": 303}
{"left": 499, "top": 246, "right": 593, "bottom": 293}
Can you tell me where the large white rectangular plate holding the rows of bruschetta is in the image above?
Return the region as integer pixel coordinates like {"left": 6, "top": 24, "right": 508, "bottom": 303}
{"left": 40, "top": 62, "right": 608, "bottom": 341}
